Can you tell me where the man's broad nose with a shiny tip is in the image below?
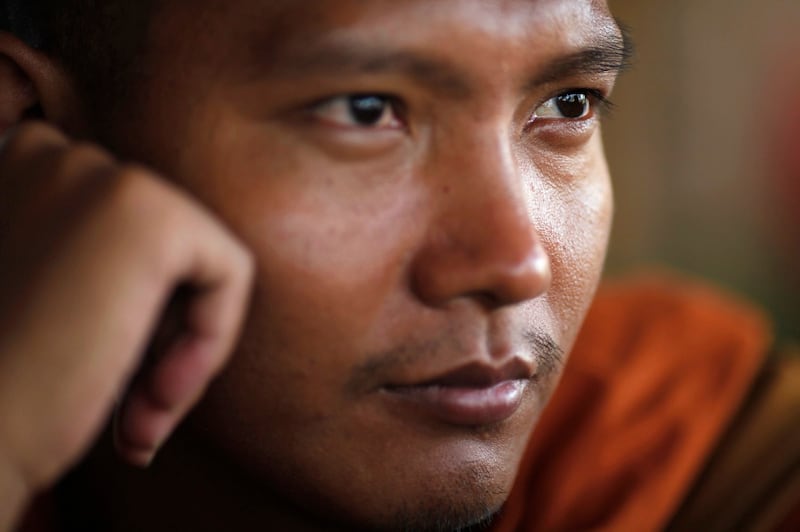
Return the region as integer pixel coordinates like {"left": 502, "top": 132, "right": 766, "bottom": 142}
{"left": 412, "top": 133, "right": 551, "bottom": 308}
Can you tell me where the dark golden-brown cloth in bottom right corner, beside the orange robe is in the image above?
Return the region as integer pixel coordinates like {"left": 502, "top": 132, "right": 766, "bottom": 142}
{"left": 671, "top": 348, "right": 800, "bottom": 532}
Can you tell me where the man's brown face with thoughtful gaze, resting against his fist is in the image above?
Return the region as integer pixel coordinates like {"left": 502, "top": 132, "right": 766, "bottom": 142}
{"left": 104, "top": 0, "right": 622, "bottom": 526}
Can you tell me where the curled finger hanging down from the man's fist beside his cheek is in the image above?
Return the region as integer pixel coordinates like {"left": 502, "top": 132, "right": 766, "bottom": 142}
{"left": 115, "top": 216, "right": 252, "bottom": 466}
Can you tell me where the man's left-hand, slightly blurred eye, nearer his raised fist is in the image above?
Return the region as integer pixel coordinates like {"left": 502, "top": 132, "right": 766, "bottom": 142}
{"left": 312, "top": 94, "right": 403, "bottom": 129}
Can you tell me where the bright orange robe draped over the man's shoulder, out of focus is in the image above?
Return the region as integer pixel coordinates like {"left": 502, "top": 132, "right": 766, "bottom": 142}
{"left": 493, "top": 278, "right": 771, "bottom": 532}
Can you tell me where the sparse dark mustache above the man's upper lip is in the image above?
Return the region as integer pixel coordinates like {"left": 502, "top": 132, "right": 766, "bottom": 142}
{"left": 348, "top": 331, "right": 565, "bottom": 392}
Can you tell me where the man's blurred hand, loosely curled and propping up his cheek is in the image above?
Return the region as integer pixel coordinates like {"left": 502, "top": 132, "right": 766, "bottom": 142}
{"left": 0, "top": 124, "right": 252, "bottom": 529}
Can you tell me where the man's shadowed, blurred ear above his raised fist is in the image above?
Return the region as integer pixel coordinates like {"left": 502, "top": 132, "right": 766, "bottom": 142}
{"left": 0, "top": 31, "right": 86, "bottom": 135}
